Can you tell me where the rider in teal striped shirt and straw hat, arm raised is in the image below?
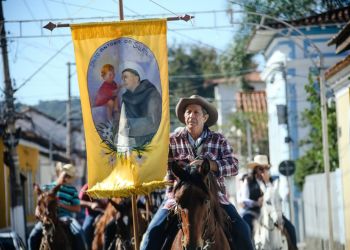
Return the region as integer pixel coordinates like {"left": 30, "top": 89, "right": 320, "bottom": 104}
{"left": 28, "top": 163, "right": 86, "bottom": 250}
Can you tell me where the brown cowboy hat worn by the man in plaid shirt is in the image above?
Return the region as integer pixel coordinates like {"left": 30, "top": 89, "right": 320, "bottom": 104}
{"left": 175, "top": 95, "right": 218, "bottom": 127}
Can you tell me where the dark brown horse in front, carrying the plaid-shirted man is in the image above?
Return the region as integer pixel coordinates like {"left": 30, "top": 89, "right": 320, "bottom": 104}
{"left": 171, "top": 160, "right": 230, "bottom": 250}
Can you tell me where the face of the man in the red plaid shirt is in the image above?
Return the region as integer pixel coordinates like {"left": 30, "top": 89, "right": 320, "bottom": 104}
{"left": 184, "top": 104, "right": 209, "bottom": 129}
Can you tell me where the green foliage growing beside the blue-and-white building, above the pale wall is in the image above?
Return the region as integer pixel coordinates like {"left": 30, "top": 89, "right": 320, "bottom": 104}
{"left": 294, "top": 75, "right": 338, "bottom": 188}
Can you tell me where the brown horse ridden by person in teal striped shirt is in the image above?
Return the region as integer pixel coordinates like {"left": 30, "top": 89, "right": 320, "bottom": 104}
{"left": 34, "top": 184, "right": 73, "bottom": 250}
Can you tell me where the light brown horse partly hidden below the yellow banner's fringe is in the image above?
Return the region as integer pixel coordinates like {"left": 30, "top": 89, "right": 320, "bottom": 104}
{"left": 92, "top": 198, "right": 148, "bottom": 250}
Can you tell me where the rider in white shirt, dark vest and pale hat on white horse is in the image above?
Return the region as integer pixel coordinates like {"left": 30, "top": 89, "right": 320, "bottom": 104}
{"left": 238, "top": 155, "right": 297, "bottom": 248}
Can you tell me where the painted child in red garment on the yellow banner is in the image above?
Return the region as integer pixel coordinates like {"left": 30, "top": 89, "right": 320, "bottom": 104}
{"left": 95, "top": 64, "right": 119, "bottom": 121}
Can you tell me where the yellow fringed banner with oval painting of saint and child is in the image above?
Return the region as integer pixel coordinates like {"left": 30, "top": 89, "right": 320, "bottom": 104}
{"left": 71, "top": 19, "right": 169, "bottom": 197}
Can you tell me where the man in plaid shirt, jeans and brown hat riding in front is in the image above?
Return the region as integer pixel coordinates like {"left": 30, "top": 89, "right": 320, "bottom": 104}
{"left": 140, "top": 95, "right": 253, "bottom": 250}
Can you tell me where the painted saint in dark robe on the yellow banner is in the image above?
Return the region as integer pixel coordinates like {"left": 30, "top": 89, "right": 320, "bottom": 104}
{"left": 118, "top": 62, "right": 162, "bottom": 151}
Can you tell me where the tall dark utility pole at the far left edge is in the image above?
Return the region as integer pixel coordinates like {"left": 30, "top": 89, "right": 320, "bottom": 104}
{"left": 0, "top": 1, "right": 26, "bottom": 241}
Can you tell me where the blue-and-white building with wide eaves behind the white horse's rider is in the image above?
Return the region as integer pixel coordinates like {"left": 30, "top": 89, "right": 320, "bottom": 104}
{"left": 248, "top": 7, "right": 350, "bottom": 242}
